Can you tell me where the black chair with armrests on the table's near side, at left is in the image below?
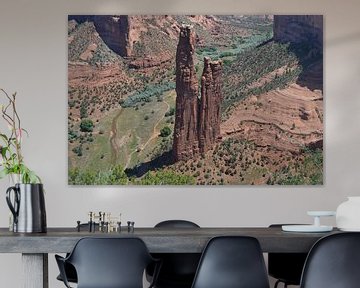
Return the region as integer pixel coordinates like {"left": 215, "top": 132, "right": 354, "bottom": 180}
{"left": 55, "top": 237, "right": 159, "bottom": 288}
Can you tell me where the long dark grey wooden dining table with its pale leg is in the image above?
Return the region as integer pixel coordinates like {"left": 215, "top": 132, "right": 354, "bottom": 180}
{"left": 0, "top": 227, "right": 338, "bottom": 288}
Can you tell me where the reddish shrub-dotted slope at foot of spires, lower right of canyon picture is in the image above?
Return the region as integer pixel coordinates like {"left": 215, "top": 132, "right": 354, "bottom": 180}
{"left": 166, "top": 138, "right": 323, "bottom": 185}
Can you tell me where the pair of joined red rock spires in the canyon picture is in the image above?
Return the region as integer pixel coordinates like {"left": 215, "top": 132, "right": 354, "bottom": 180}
{"left": 173, "top": 25, "right": 222, "bottom": 161}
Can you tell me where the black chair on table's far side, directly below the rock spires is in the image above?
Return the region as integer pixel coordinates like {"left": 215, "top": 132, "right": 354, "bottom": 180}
{"left": 147, "top": 220, "right": 201, "bottom": 288}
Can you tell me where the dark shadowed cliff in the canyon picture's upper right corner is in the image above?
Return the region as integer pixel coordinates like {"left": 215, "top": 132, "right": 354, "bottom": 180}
{"left": 274, "top": 15, "right": 323, "bottom": 49}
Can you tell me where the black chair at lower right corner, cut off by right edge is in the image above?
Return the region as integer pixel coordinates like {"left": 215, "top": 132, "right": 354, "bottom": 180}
{"left": 300, "top": 232, "right": 360, "bottom": 288}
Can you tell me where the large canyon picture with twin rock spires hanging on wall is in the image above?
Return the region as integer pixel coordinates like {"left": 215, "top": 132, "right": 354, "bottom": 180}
{"left": 67, "top": 15, "right": 324, "bottom": 185}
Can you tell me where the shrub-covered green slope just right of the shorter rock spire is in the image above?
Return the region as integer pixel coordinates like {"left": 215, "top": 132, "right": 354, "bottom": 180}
{"left": 222, "top": 43, "right": 301, "bottom": 112}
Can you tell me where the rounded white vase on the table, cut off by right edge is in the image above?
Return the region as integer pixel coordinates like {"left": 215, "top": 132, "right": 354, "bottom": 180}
{"left": 336, "top": 196, "right": 360, "bottom": 231}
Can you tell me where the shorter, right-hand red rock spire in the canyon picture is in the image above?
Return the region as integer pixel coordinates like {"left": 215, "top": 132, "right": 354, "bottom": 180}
{"left": 198, "top": 57, "right": 222, "bottom": 153}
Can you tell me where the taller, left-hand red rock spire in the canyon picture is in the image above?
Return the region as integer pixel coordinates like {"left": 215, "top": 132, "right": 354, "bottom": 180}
{"left": 173, "top": 25, "right": 199, "bottom": 161}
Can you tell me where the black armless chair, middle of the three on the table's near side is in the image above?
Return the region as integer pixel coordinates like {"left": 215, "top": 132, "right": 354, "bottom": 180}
{"left": 192, "top": 236, "right": 269, "bottom": 288}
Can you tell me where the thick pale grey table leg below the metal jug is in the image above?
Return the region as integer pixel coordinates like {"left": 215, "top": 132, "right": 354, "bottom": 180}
{"left": 22, "top": 253, "right": 49, "bottom": 288}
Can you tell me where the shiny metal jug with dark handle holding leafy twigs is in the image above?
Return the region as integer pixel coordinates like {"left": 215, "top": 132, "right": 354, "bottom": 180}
{"left": 6, "top": 184, "right": 47, "bottom": 233}
